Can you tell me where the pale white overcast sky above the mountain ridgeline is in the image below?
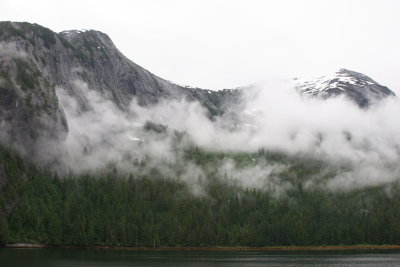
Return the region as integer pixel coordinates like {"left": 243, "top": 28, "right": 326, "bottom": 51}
{"left": 0, "top": 0, "right": 400, "bottom": 92}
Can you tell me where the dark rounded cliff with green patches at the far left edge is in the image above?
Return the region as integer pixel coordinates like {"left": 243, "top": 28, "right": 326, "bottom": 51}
{"left": 0, "top": 23, "right": 68, "bottom": 154}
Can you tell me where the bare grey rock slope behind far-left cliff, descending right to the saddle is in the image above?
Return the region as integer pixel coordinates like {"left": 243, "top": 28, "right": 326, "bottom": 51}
{"left": 60, "top": 27, "right": 238, "bottom": 113}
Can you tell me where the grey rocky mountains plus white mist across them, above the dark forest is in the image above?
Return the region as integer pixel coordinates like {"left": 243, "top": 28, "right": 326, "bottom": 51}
{"left": 0, "top": 19, "right": 399, "bottom": 183}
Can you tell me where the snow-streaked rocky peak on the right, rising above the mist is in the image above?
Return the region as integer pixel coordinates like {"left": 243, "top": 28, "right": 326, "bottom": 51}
{"left": 297, "top": 69, "right": 394, "bottom": 108}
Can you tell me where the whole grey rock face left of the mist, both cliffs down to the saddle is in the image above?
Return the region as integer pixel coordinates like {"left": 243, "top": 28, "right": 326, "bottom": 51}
{"left": 0, "top": 22, "right": 239, "bottom": 156}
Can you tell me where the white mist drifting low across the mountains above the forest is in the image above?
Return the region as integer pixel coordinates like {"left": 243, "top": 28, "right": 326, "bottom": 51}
{"left": 51, "top": 79, "right": 400, "bottom": 196}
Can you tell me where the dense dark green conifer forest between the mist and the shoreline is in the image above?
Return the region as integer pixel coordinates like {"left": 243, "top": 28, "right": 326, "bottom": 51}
{"left": 0, "top": 143, "right": 400, "bottom": 246}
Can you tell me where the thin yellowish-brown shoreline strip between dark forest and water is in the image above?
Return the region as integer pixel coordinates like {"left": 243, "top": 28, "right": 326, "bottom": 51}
{"left": 1, "top": 243, "right": 400, "bottom": 251}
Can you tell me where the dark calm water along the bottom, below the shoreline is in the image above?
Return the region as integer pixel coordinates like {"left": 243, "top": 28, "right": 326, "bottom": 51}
{"left": 0, "top": 249, "right": 400, "bottom": 267}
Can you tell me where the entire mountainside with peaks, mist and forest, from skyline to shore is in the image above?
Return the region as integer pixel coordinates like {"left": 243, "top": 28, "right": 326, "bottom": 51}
{"left": 0, "top": 22, "right": 400, "bottom": 247}
